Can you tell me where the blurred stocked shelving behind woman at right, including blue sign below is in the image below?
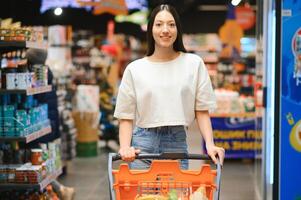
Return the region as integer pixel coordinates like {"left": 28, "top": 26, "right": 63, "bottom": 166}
{"left": 183, "top": 34, "right": 262, "bottom": 159}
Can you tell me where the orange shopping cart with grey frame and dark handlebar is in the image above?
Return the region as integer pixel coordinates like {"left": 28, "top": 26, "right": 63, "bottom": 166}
{"left": 108, "top": 153, "right": 221, "bottom": 200}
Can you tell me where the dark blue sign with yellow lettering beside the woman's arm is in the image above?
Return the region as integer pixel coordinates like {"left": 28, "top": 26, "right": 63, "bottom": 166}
{"left": 211, "top": 116, "right": 261, "bottom": 158}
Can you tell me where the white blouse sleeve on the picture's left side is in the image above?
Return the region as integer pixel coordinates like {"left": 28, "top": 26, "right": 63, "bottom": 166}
{"left": 114, "top": 68, "right": 136, "bottom": 119}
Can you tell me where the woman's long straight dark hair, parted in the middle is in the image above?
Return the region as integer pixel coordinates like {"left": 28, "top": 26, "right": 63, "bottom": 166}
{"left": 146, "top": 4, "right": 186, "bottom": 56}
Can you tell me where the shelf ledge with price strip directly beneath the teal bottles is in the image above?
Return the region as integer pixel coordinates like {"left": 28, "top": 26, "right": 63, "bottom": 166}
{"left": 0, "top": 126, "right": 51, "bottom": 143}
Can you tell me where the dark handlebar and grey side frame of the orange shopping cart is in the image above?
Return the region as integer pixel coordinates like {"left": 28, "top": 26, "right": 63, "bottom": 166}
{"left": 108, "top": 153, "right": 222, "bottom": 200}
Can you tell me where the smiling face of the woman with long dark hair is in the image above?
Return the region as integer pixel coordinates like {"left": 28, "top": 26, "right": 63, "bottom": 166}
{"left": 152, "top": 10, "right": 177, "bottom": 48}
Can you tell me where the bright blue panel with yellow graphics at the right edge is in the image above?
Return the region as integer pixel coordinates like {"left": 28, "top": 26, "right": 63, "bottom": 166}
{"left": 276, "top": 0, "right": 301, "bottom": 200}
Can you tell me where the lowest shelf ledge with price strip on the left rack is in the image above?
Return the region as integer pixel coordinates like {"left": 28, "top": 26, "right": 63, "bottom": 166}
{"left": 0, "top": 168, "right": 62, "bottom": 191}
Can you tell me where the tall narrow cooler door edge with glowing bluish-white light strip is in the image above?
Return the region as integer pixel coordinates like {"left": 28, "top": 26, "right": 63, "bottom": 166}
{"left": 258, "top": 0, "right": 279, "bottom": 200}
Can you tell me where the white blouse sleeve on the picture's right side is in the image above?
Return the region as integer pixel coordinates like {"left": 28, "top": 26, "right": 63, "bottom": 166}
{"left": 195, "top": 60, "right": 216, "bottom": 112}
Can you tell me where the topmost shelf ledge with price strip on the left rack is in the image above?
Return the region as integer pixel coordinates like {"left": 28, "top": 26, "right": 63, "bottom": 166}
{"left": 0, "top": 41, "right": 48, "bottom": 49}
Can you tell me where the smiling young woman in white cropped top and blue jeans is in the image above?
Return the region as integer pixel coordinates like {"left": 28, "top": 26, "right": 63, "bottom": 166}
{"left": 114, "top": 4, "right": 225, "bottom": 169}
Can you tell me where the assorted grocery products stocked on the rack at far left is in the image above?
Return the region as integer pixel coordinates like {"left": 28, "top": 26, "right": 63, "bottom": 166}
{"left": 0, "top": 19, "right": 62, "bottom": 195}
